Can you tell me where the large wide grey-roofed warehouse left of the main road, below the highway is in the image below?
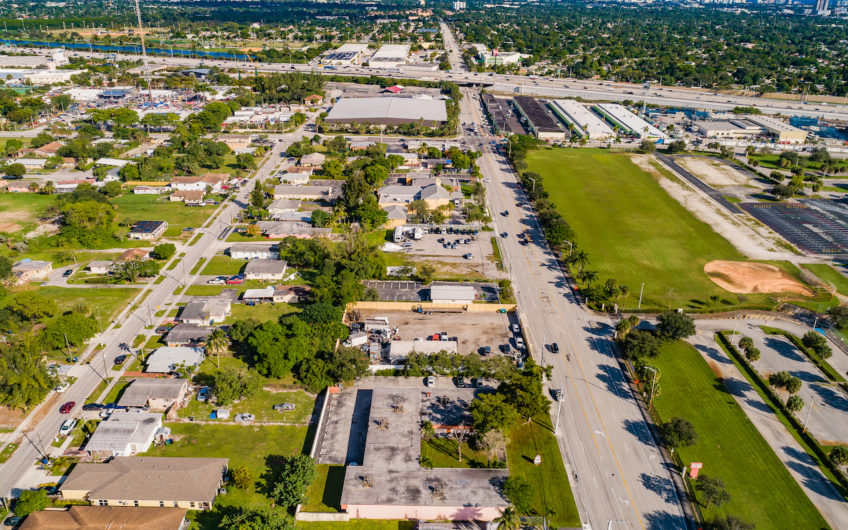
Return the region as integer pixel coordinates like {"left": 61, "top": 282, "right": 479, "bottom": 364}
{"left": 324, "top": 97, "right": 448, "bottom": 127}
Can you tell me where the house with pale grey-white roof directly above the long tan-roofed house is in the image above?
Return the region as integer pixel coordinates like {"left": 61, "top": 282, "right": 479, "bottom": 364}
{"left": 84, "top": 410, "right": 162, "bottom": 457}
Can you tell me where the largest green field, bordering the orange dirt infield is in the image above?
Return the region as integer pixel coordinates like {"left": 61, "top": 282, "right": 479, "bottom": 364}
{"left": 527, "top": 149, "right": 768, "bottom": 309}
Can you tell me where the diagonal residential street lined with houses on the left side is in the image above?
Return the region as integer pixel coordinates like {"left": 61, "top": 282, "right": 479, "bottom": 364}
{"left": 0, "top": 138, "right": 283, "bottom": 496}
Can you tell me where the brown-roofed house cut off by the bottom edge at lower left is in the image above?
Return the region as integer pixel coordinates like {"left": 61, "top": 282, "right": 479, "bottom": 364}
{"left": 20, "top": 505, "right": 187, "bottom": 530}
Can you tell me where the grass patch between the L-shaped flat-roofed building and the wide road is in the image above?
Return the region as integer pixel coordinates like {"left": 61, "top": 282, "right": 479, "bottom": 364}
{"left": 506, "top": 416, "right": 580, "bottom": 527}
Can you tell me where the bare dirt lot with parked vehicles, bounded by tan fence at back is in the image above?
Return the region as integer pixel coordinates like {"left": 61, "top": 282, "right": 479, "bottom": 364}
{"left": 359, "top": 309, "right": 517, "bottom": 353}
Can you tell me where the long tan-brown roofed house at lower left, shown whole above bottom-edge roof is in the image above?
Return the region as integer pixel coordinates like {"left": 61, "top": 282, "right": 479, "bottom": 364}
{"left": 60, "top": 456, "right": 229, "bottom": 510}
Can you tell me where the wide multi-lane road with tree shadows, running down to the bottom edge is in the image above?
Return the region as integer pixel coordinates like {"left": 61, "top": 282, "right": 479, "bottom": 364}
{"left": 461, "top": 91, "right": 687, "bottom": 529}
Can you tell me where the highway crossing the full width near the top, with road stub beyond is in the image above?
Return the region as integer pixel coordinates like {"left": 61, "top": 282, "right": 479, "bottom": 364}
{"left": 17, "top": 43, "right": 848, "bottom": 120}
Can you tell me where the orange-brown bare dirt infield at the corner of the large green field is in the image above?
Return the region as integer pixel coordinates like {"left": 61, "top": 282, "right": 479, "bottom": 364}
{"left": 704, "top": 260, "right": 814, "bottom": 296}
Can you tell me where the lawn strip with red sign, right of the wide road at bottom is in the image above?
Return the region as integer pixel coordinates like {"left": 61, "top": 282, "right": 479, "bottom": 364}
{"left": 649, "top": 342, "right": 828, "bottom": 529}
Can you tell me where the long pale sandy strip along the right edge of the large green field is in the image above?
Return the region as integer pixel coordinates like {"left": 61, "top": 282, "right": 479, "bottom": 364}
{"left": 630, "top": 155, "right": 798, "bottom": 260}
